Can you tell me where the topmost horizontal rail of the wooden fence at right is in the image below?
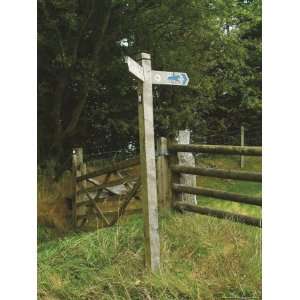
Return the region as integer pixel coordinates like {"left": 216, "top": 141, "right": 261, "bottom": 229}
{"left": 168, "top": 143, "right": 262, "bottom": 156}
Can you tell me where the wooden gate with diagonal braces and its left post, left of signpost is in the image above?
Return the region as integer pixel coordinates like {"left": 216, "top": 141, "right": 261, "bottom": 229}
{"left": 72, "top": 148, "right": 142, "bottom": 228}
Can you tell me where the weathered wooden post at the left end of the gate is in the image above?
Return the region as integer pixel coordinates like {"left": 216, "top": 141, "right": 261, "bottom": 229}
{"left": 72, "top": 148, "right": 83, "bottom": 228}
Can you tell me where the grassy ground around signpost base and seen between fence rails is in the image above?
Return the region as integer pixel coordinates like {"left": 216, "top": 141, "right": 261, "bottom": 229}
{"left": 38, "top": 156, "right": 261, "bottom": 300}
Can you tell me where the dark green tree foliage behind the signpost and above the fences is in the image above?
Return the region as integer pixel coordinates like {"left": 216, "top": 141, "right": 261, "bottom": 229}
{"left": 38, "top": 0, "right": 261, "bottom": 169}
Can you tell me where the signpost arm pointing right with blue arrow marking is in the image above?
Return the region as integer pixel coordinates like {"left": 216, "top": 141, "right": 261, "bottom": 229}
{"left": 152, "top": 70, "right": 189, "bottom": 86}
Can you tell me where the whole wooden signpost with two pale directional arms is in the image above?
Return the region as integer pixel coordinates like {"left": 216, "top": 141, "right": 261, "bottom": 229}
{"left": 125, "top": 53, "right": 189, "bottom": 272}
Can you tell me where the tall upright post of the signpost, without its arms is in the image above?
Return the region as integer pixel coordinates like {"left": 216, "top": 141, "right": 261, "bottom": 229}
{"left": 138, "top": 53, "right": 160, "bottom": 272}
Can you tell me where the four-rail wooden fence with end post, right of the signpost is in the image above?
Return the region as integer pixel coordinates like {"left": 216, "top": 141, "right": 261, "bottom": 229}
{"left": 158, "top": 138, "right": 262, "bottom": 227}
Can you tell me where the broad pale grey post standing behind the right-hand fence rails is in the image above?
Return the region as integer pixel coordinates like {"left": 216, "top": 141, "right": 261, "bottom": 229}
{"left": 177, "top": 129, "right": 197, "bottom": 204}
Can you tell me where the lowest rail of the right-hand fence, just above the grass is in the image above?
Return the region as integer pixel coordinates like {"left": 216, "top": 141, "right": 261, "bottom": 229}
{"left": 174, "top": 202, "right": 261, "bottom": 227}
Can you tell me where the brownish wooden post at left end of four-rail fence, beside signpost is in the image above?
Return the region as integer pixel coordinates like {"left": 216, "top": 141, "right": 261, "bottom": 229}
{"left": 157, "top": 137, "right": 170, "bottom": 207}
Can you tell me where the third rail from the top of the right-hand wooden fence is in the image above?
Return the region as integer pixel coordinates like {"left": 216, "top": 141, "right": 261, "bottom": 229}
{"left": 172, "top": 183, "right": 262, "bottom": 206}
